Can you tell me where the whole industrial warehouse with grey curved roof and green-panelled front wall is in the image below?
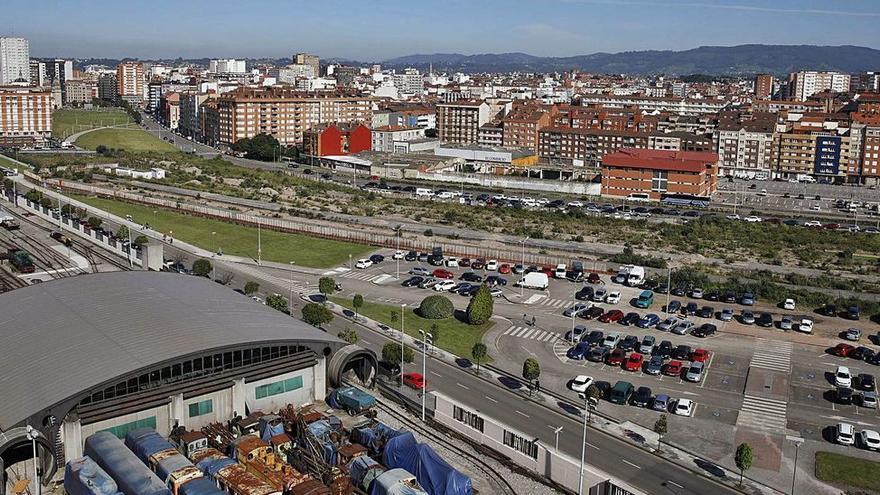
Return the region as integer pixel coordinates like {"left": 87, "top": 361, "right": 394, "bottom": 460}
{"left": 0, "top": 272, "right": 376, "bottom": 483}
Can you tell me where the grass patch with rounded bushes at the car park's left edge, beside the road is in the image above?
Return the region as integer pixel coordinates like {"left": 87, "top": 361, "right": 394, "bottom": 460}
{"left": 330, "top": 296, "right": 495, "bottom": 364}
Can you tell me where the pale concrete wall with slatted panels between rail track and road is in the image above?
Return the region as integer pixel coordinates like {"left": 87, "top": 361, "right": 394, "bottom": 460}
{"left": 431, "top": 391, "right": 643, "bottom": 495}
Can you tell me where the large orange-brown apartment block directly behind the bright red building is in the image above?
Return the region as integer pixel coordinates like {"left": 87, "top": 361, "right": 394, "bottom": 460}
{"left": 217, "top": 87, "right": 374, "bottom": 146}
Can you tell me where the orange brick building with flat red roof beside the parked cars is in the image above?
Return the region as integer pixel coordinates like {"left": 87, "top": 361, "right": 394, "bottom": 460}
{"left": 602, "top": 148, "right": 718, "bottom": 200}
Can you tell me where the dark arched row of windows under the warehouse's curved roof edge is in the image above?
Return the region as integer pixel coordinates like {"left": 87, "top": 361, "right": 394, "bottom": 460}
{"left": 80, "top": 346, "right": 307, "bottom": 405}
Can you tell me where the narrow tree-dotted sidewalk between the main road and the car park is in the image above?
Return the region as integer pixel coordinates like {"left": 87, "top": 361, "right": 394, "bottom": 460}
{"left": 316, "top": 295, "right": 780, "bottom": 494}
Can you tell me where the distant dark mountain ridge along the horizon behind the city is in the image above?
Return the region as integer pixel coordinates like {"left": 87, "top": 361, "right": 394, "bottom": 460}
{"left": 382, "top": 45, "right": 880, "bottom": 75}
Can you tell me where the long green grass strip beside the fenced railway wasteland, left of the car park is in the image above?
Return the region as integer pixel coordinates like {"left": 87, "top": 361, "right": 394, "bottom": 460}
{"left": 73, "top": 196, "right": 373, "bottom": 268}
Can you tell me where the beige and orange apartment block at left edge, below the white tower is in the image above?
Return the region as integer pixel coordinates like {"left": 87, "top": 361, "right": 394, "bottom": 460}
{"left": 0, "top": 86, "right": 53, "bottom": 147}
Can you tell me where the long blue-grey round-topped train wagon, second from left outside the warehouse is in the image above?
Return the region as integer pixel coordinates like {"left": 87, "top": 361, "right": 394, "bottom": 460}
{"left": 83, "top": 431, "right": 171, "bottom": 495}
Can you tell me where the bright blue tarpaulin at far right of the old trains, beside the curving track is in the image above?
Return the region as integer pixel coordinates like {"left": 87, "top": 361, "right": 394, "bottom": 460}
{"left": 382, "top": 432, "right": 473, "bottom": 495}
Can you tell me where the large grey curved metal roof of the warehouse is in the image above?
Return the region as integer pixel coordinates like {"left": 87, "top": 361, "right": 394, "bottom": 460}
{"left": 0, "top": 271, "right": 344, "bottom": 431}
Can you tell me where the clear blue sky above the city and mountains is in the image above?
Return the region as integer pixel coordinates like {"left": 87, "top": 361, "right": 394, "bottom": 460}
{"left": 6, "top": 0, "right": 880, "bottom": 61}
